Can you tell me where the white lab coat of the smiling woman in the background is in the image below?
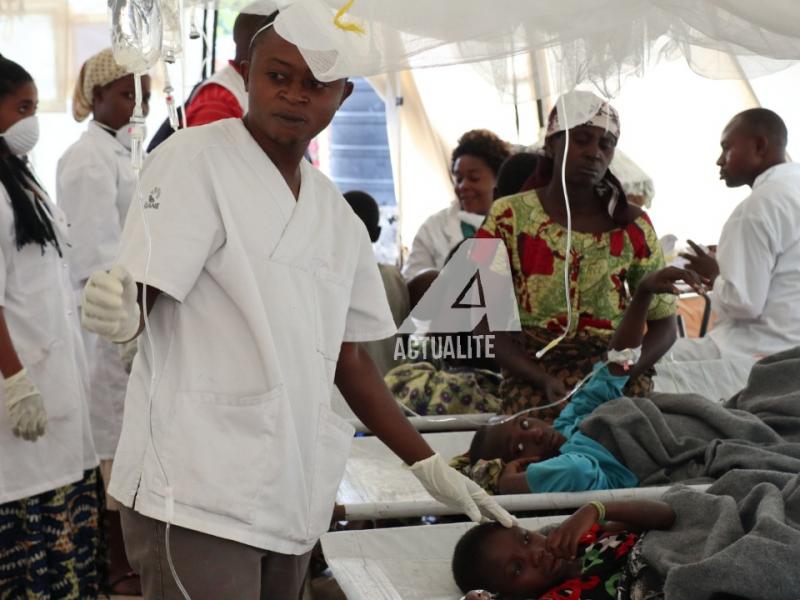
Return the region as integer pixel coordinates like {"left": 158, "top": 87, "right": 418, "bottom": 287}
{"left": 403, "top": 199, "right": 484, "bottom": 281}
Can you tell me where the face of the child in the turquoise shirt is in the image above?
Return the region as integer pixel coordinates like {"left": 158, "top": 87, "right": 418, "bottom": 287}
{"left": 483, "top": 415, "right": 566, "bottom": 462}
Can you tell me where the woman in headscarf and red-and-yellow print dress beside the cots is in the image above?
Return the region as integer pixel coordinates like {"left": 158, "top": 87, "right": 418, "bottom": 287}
{"left": 476, "top": 92, "right": 676, "bottom": 421}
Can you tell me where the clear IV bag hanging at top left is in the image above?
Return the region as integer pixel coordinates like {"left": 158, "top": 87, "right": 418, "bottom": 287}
{"left": 108, "top": 0, "right": 162, "bottom": 73}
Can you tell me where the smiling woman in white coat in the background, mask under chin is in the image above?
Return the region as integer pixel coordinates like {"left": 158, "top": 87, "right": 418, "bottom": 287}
{"left": 403, "top": 129, "right": 511, "bottom": 280}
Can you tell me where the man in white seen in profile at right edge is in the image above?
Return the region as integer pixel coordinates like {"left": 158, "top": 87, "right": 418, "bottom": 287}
{"left": 671, "top": 108, "right": 800, "bottom": 360}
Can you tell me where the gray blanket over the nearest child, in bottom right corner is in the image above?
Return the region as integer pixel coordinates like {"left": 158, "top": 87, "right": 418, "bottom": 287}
{"left": 642, "top": 471, "right": 800, "bottom": 600}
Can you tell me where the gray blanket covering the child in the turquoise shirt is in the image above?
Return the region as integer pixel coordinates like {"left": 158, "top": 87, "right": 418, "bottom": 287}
{"left": 581, "top": 348, "right": 800, "bottom": 482}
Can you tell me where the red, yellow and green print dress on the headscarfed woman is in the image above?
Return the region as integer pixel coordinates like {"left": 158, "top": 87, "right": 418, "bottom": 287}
{"left": 476, "top": 190, "right": 676, "bottom": 421}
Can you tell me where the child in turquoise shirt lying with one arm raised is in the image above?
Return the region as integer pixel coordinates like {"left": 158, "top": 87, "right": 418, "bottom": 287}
{"left": 460, "top": 267, "right": 703, "bottom": 494}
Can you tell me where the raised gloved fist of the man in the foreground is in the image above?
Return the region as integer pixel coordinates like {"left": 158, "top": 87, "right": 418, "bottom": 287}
{"left": 81, "top": 266, "right": 140, "bottom": 342}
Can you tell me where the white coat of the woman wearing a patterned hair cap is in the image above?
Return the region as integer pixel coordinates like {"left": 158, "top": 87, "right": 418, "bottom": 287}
{"left": 56, "top": 121, "right": 136, "bottom": 459}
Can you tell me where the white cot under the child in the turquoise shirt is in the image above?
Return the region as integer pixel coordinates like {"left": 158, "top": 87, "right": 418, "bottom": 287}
{"left": 336, "top": 431, "right": 708, "bottom": 521}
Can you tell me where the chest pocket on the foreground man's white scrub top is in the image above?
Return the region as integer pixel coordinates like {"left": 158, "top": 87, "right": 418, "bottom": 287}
{"left": 313, "top": 267, "right": 350, "bottom": 361}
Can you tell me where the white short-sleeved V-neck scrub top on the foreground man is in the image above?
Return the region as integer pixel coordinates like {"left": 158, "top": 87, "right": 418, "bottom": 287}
{"left": 109, "top": 119, "right": 395, "bottom": 554}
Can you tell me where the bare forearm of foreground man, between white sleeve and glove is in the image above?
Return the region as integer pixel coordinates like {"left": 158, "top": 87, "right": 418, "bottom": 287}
{"left": 335, "top": 342, "right": 433, "bottom": 465}
